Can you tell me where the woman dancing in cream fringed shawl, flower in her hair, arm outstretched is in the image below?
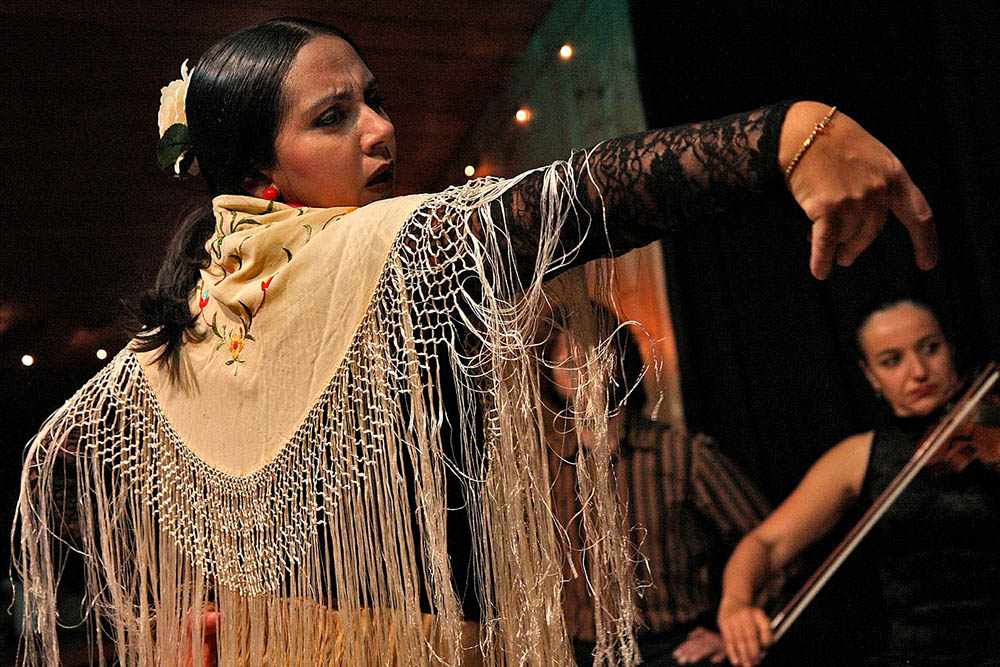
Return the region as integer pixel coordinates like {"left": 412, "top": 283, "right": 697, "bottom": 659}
{"left": 17, "top": 19, "right": 936, "bottom": 665}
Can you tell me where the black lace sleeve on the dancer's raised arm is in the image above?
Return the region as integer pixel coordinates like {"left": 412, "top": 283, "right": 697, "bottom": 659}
{"left": 502, "top": 102, "right": 791, "bottom": 276}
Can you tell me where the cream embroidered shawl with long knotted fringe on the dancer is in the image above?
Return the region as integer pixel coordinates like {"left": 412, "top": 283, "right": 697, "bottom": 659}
{"left": 15, "top": 163, "right": 637, "bottom": 665}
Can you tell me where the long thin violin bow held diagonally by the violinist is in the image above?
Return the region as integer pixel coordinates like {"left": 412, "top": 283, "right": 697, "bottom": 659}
{"left": 771, "top": 362, "right": 1000, "bottom": 642}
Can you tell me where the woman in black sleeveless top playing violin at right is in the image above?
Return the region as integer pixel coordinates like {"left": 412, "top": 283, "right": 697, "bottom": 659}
{"left": 719, "top": 298, "right": 1000, "bottom": 665}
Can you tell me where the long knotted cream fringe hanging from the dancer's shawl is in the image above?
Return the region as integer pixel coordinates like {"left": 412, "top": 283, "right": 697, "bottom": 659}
{"left": 12, "top": 155, "right": 638, "bottom": 665}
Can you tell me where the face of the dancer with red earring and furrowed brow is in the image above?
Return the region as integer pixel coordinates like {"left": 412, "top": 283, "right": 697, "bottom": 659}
{"left": 260, "top": 35, "right": 396, "bottom": 206}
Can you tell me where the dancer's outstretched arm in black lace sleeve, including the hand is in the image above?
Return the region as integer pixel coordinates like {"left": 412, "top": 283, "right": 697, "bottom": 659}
{"left": 504, "top": 102, "right": 937, "bottom": 278}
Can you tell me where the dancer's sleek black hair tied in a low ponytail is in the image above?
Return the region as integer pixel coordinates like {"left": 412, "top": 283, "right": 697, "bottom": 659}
{"left": 128, "top": 17, "right": 360, "bottom": 363}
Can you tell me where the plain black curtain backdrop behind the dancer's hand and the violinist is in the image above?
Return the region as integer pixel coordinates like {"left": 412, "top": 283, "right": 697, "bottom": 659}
{"left": 632, "top": 0, "right": 1000, "bottom": 664}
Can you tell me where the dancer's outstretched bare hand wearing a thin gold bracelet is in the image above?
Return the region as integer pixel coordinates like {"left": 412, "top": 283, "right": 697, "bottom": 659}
{"left": 778, "top": 102, "right": 938, "bottom": 279}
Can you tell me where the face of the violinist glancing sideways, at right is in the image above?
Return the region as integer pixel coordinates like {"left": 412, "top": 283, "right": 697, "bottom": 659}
{"left": 858, "top": 301, "right": 958, "bottom": 417}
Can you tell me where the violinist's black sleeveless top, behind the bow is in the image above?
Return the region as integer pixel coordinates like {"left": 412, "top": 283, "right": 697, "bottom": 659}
{"left": 861, "top": 419, "right": 1000, "bottom": 667}
